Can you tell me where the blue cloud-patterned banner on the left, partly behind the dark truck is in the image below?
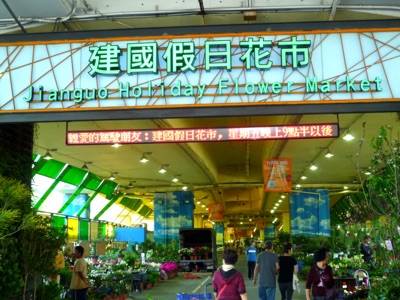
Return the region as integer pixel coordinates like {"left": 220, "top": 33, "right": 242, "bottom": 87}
{"left": 154, "top": 192, "right": 194, "bottom": 243}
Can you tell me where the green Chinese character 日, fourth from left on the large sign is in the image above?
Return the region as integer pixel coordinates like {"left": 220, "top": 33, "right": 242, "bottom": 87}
{"left": 205, "top": 40, "right": 232, "bottom": 71}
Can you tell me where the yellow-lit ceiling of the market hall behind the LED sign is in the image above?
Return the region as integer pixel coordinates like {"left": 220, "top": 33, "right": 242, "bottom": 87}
{"left": 34, "top": 113, "right": 400, "bottom": 225}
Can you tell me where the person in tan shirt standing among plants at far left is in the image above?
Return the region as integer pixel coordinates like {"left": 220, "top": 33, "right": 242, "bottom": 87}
{"left": 70, "top": 246, "right": 89, "bottom": 300}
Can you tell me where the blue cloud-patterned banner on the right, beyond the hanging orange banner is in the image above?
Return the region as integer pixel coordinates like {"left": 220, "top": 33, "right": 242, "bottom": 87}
{"left": 290, "top": 189, "right": 331, "bottom": 236}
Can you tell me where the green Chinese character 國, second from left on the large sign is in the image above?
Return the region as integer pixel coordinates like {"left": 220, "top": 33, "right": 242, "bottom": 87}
{"left": 126, "top": 42, "right": 157, "bottom": 74}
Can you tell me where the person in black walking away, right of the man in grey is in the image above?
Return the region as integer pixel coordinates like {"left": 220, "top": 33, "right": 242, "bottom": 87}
{"left": 278, "top": 244, "right": 298, "bottom": 300}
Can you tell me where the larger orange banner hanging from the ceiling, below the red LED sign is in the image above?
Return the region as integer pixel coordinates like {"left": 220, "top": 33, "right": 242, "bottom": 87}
{"left": 263, "top": 158, "right": 292, "bottom": 192}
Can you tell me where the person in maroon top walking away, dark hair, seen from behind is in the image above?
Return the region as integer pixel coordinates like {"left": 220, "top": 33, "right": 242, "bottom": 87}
{"left": 212, "top": 249, "right": 247, "bottom": 300}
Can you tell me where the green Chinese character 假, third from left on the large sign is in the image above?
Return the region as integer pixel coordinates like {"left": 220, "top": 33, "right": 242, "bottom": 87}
{"left": 163, "top": 42, "right": 196, "bottom": 72}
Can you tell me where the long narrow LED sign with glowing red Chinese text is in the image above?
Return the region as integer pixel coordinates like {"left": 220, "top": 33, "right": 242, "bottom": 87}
{"left": 66, "top": 124, "right": 339, "bottom": 145}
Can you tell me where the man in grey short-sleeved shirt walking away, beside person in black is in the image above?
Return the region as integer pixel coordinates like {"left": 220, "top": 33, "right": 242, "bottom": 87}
{"left": 253, "top": 241, "right": 279, "bottom": 300}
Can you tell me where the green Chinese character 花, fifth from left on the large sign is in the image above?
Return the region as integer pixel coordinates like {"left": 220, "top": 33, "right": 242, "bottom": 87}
{"left": 239, "top": 37, "right": 272, "bottom": 69}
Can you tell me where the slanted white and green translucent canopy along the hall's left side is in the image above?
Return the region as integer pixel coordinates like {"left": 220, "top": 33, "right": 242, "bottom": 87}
{"left": 33, "top": 155, "right": 153, "bottom": 225}
